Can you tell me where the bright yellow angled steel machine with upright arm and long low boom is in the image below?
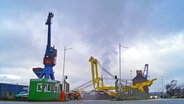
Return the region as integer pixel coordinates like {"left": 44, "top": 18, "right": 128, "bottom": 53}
{"left": 89, "top": 56, "right": 156, "bottom": 96}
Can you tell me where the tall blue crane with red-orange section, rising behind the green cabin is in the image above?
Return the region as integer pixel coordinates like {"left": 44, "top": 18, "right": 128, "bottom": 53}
{"left": 33, "top": 13, "right": 57, "bottom": 80}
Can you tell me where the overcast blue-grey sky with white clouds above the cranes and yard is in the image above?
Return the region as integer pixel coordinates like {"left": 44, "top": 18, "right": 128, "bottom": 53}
{"left": 0, "top": 0, "right": 184, "bottom": 91}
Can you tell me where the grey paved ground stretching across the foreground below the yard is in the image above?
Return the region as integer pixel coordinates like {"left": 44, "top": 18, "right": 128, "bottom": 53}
{"left": 0, "top": 99, "right": 184, "bottom": 104}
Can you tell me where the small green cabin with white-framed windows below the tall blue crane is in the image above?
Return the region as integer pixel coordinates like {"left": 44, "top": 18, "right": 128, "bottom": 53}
{"left": 28, "top": 78, "right": 60, "bottom": 101}
